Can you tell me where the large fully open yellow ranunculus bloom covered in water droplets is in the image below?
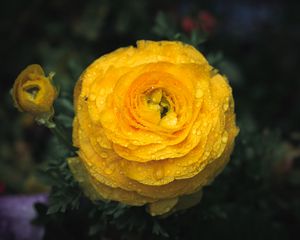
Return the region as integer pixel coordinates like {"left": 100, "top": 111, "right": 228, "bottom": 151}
{"left": 69, "top": 41, "right": 238, "bottom": 215}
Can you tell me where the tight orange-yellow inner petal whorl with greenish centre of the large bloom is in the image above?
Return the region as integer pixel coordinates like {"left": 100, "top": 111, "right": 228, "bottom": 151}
{"left": 124, "top": 72, "right": 193, "bottom": 137}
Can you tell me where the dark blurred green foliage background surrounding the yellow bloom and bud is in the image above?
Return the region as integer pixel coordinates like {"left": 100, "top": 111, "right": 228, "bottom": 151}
{"left": 0, "top": 0, "right": 300, "bottom": 239}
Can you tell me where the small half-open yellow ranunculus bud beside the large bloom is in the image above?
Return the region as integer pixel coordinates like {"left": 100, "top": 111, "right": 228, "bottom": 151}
{"left": 12, "top": 64, "right": 57, "bottom": 119}
